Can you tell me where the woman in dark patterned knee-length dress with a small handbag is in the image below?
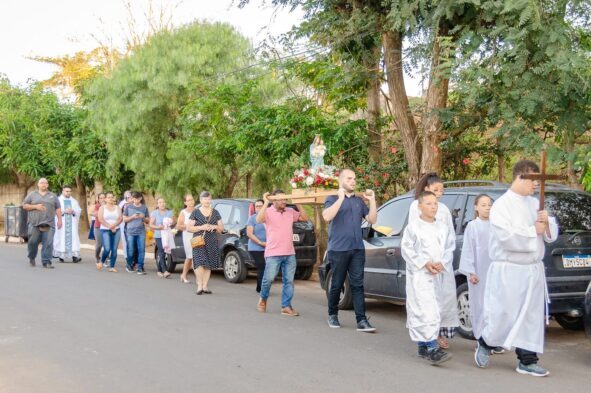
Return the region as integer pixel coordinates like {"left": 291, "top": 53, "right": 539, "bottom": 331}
{"left": 188, "top": 191, "right": 224, "bottom": 295}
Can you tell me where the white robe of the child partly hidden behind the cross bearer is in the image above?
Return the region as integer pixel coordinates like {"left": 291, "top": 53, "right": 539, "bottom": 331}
{"left": 459, "top": 218, "right": 491, "bottom": 338}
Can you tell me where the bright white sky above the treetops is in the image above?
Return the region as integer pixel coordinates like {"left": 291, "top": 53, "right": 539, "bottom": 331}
{"left": 0, "top": 0, "right": 419, "bottom": 95}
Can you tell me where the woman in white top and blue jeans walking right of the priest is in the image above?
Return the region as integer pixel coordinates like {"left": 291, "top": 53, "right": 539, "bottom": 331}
{"left": 96, "top": 192, "right": 123, "bottom": 273}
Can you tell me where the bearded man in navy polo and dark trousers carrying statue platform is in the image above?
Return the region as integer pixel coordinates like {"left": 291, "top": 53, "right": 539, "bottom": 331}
{"left": 322, "top": 169, "right": 377, "bottom": 332}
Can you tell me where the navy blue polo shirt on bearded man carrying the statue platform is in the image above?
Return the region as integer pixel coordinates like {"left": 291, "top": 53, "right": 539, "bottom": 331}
{"left": 324, "top": 195, "right": 369, "bottom": 251}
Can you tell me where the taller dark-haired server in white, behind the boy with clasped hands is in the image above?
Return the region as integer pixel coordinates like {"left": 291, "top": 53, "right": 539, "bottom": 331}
{"left": 408, "top": 173, "right": 460, "bottom": 349}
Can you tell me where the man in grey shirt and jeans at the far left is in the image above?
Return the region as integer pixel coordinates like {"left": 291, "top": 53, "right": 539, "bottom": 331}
{"left": 23, "top": 178, "right": 62, "bottom": 269}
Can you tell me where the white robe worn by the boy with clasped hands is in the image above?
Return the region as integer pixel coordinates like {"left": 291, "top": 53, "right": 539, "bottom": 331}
{"left": 401, "top": 218, "right": 457, "bottom": 341}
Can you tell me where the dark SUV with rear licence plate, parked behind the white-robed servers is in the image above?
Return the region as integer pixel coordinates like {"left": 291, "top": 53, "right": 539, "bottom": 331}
{"left": 318, "top": 181, "right": 591, "bottom": 338}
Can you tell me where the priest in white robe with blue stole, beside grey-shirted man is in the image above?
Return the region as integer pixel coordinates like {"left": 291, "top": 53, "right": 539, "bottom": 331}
{"left": 53, "top": 186, "right": 82, "bottom": 262}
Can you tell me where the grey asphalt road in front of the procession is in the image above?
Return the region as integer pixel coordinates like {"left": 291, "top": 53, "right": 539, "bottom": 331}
{"left": 0, "top": 244, "right": 591, "bottom": 393}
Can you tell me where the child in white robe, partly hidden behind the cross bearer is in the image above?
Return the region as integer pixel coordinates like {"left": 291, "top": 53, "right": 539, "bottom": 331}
{"left": 458, "top": 194, "right": 505, "bottom": 353}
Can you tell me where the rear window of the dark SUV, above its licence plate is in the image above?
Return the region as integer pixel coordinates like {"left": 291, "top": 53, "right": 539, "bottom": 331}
{"left": 545, "top": 192, "right": 591, "bottom": 233}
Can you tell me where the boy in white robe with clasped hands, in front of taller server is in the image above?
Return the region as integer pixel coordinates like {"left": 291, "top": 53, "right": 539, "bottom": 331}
{"left": 401, "top": 191, "right": 455, "bottom": 364}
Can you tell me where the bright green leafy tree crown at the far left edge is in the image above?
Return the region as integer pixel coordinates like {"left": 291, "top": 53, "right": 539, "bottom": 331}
{"left": 0, "top": 80, "right": 107, "bottom": 190}
